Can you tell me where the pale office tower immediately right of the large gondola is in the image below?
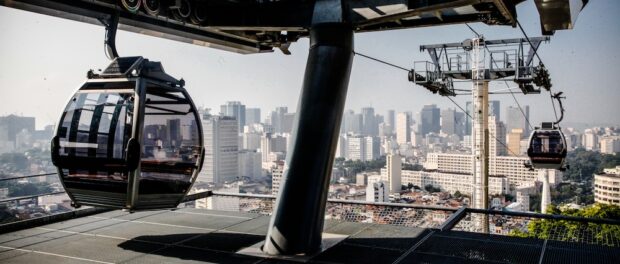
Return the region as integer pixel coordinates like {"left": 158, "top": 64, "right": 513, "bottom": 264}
{"left": 198, "top": 116, "right": 239, "bottom": 184}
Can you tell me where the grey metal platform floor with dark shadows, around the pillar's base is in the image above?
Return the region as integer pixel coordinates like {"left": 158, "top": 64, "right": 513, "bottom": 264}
{"left": 0, "top": 208, "right": 620, "bottom": 263}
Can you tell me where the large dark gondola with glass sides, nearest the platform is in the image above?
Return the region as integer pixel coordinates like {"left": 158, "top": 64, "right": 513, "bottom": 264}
{"left": 52, "top": 57, "right": 204, "bottom": 210}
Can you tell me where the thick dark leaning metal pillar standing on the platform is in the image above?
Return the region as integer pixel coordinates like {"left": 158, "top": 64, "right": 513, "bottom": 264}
{"left": 263, "top": 23, "right": 353, "bottom": 255}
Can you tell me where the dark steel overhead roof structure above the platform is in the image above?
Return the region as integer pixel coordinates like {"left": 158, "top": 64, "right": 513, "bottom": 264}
{"left": 0, "top": 0, "right": 524, "bottom": 54}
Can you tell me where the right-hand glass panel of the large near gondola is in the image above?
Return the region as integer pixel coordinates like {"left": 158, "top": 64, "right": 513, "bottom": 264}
{"left": 139, "top": 83, "right": 201, "bottom": 206}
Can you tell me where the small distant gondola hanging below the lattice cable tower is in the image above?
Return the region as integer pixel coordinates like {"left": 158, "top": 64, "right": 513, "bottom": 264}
{"left": 527, "top": 122, "right": 567, "bottom": 169}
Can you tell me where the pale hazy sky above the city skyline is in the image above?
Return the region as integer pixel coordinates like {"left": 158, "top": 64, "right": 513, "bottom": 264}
{"left": 0, "top": 0, "right": 620, "bottom": 128}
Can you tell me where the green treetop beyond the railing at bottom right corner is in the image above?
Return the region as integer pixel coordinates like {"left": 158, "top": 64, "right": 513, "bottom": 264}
{"left": 510, "top": 203, "right": 620, "bottom": 246}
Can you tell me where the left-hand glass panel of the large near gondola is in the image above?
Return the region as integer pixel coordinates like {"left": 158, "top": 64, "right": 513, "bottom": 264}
{"left": 55, "top": 82, "right": 135, "bottom": 206}
